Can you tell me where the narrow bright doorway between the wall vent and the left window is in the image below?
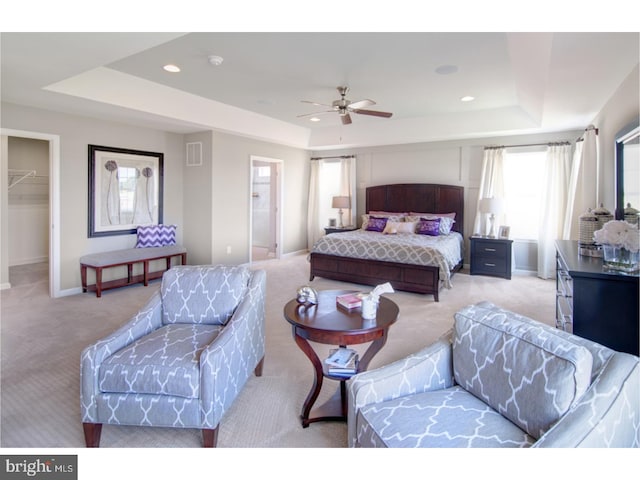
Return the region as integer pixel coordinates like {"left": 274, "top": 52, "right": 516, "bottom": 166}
{"left": 249, "top": 155, "right": 282, "bottom": 262}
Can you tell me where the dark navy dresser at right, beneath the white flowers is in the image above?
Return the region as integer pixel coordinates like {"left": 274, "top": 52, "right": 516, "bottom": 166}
{"left": 556, "top": 240, "right": 639, "bottom": 355}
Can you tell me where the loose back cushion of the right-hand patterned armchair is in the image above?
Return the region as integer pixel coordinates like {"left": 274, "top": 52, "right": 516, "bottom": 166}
{"left": 453, "top": 302, "right": 593, "bottom": 438}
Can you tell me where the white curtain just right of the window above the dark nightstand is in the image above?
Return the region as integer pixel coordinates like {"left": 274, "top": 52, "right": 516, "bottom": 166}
{"left": 538, "top": 144, "right": 571, "bottom": 279}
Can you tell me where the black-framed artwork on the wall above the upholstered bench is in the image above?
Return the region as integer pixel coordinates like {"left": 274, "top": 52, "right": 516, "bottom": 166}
{"left": 89, "top": 145, "right": 164, "bottom": 237}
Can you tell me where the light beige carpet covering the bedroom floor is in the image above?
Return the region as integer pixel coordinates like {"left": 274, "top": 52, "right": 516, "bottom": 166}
{"left": 0, "top": 255, "right": 555, "bottom": 448}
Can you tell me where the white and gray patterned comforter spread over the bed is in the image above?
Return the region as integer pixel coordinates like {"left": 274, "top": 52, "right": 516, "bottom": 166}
{"left": 311, "top": 229, "right": 463, "bottom": 288}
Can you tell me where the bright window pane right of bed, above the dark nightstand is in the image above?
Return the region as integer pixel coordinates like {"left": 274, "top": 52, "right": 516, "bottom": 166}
{"left": 504, "top": 147, "right": 546, "bottom": 240}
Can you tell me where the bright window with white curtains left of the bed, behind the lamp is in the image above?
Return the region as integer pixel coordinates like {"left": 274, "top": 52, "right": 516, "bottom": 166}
{"left": 307, "top": 157, "right": 357, "bottom": 250}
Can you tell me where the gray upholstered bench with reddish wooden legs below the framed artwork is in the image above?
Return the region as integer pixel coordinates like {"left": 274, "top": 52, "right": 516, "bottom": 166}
{"left": 80, "top": 245, "right": 187, "bottom": 297}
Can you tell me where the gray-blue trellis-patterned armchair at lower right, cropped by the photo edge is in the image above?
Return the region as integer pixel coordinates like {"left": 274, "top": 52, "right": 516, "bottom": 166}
{"left": 347, "top": 302, "right": 640, "bottom": 448}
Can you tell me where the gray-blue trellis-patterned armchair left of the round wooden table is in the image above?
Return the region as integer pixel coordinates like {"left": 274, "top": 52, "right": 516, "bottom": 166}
{"left": 80, "top": 265, "right": 266, "bottom": 447}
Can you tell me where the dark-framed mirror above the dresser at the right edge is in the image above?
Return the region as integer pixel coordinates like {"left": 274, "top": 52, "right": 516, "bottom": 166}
{"left": 616, "top": 119, "right": 640, "bottom": 220}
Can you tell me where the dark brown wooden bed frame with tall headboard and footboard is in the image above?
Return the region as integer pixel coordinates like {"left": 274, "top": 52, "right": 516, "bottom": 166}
{"left": 309, "top": 183, "right": 464, "bottom": 302}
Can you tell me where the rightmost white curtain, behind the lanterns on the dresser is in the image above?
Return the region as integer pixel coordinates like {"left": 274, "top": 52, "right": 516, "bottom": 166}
{"left": 562, "top": 126, "right": 599, "bottom": 240}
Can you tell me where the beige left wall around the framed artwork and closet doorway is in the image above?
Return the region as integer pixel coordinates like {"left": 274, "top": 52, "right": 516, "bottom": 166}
{"left": 2, "top": 103, "right": 184, "bottom": 294}
